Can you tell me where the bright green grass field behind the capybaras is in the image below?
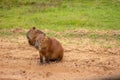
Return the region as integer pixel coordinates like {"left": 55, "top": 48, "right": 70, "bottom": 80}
{"left": 0, "top": 0, "right": 120, "bottom": 31}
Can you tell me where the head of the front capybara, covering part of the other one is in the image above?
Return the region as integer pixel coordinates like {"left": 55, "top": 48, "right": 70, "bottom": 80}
{"left": 35, "top": 34, "right": 48, "bottom": 49}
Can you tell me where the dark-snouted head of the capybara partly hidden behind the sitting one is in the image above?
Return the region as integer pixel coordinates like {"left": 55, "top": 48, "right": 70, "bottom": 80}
{"left": 27, "top": 27, "right": 45, "bottom": 46}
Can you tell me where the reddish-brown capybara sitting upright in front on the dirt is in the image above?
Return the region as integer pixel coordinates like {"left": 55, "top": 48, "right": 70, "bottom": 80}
{"left": 35, "top": 34, "right": 64, "bottom": 64}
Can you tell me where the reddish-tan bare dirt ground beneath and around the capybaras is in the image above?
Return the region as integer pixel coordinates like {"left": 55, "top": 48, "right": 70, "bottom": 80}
{"left": 0, "top": 29, "right": 120, "bottom": 80}
